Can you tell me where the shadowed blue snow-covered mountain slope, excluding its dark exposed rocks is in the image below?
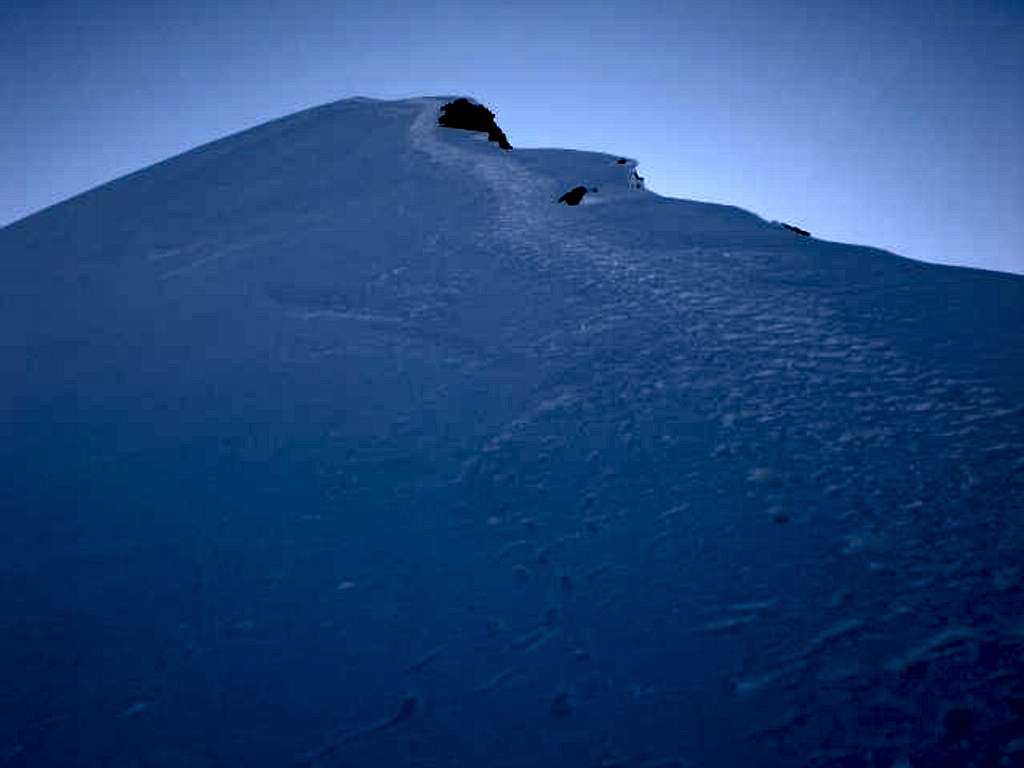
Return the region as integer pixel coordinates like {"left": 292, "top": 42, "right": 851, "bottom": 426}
{"left": 0, "top": 98, "right": 1024, "bottom": 768}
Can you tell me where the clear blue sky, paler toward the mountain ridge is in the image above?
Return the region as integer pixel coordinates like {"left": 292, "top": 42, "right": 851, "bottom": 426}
{"left": 0, "top": 0, "right": 1024, "bottom": 272}
